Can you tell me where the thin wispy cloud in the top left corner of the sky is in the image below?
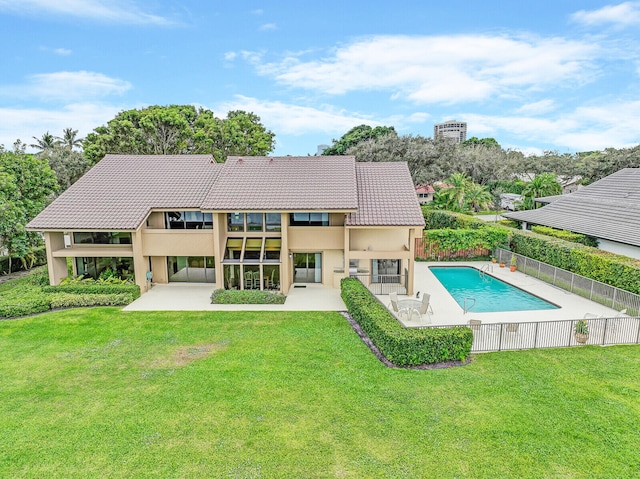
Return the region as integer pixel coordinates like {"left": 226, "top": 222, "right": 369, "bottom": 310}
{"left": 0, "top": 0, "right": 176, "bottom": 26}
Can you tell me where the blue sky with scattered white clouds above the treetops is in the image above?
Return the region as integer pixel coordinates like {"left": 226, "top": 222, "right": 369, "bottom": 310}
{"left": 0, "top": 0, "right": 640, "bottom": 155}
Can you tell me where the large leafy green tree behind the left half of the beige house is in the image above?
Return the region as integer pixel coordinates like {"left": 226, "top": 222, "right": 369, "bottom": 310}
{"left": 83, "top": 105, "right": 275, "bottom": 164}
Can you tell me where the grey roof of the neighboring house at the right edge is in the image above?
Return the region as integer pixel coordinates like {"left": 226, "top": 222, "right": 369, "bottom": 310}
{"left": 503, "top": 168, "right": 640, "bottom": 259}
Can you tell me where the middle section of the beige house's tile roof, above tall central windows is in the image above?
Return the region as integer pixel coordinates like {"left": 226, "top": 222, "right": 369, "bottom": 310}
{"left": 202, "top": 156, "right": 358, "bottom": 211}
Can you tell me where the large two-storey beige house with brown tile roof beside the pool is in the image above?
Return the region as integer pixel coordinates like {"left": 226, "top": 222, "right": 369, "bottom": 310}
{"left": 27, "top": 155, "right": 424, "bottom": 294}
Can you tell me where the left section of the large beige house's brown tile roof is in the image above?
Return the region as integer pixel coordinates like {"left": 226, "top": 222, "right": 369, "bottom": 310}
{"left": 27, "top": 155, "right": 222, "bottom": 230}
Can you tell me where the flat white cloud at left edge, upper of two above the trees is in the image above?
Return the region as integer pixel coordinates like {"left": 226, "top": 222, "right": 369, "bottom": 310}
{"left": 0, "top": 71, "right": 131, "bottom": 102}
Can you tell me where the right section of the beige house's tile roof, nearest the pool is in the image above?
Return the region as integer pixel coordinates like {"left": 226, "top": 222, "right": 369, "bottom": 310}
{"left": 345, "top": 161, "right": 425, "bottom": 227}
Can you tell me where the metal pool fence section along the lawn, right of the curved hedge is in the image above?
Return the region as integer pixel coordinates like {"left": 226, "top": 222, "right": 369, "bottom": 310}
{"left": 427, "top": 316, "right": 640, "bottom": 353}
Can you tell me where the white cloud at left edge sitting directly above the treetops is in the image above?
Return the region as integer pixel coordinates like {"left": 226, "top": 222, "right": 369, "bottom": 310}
{"left": 0, "top": 103, "right": 123, "bottom": 148}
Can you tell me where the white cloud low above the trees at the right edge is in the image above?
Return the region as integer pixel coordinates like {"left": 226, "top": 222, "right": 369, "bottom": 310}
{"left": 464, "top": 100, "right": 640, "bottom": 151}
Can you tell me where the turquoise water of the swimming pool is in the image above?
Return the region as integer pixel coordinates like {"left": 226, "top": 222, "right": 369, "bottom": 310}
{"left": 429, "top": 266, "right": 558, "bottom": 313}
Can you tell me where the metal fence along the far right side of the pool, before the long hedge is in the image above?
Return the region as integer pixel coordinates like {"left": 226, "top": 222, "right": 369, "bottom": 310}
{"left": 496, "top": 248, "right": 640, "bottom": 316}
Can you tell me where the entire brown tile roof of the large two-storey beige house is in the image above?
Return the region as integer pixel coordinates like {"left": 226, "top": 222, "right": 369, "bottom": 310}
{"left": 27, "top": 155, "right": 424, "bottom": 230}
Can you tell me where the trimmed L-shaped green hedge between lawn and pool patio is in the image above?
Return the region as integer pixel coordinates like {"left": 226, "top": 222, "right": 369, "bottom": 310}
{"left": 340, "top": 278, "right": 473, "bottom": 366}
